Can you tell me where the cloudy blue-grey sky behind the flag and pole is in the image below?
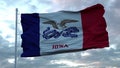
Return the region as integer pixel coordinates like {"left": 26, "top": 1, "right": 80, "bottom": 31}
{"left": 0, "top": 0, "right": 120, "bottom": 68}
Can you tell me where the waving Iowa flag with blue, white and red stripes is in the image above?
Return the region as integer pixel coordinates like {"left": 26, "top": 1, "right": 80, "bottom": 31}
{"left": 21, "top": 4, "right": 109, "bottom": 57}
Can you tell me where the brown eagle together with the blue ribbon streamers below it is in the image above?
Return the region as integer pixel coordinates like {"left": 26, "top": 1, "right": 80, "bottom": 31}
{"left": 42, "top": 17, "right": 79, "bottom": 39}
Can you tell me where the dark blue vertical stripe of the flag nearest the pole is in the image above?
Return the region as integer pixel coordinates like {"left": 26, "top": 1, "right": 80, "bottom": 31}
{"left": 21, "top": 13, "right": 40, "bottom": 57}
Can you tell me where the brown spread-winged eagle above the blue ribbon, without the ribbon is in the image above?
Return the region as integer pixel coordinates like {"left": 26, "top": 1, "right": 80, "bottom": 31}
{"left": 43, "top": 19, "right": 78, "bottom": 29}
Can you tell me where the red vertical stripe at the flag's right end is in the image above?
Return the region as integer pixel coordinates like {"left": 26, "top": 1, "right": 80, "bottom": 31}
{"left": 80, "top": 4, "right": 109, "bottom": 49}
